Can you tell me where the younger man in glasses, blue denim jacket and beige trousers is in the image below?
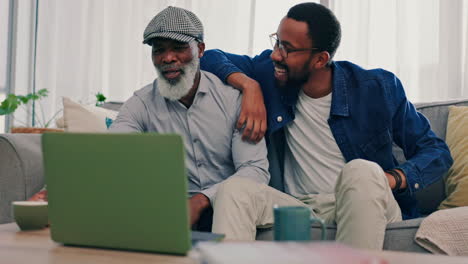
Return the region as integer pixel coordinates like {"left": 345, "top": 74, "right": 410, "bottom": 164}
{"left": 202, "top": 3, "right": 452, "bottom": 249}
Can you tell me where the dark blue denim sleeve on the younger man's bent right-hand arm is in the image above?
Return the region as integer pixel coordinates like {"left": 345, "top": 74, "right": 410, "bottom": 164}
{"left": 389, "top": 74, "right": 453, "bottom": 196}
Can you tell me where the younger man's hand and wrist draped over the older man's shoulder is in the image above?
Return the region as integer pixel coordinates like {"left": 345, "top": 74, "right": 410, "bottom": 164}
{"left": 227, "top": 72, "right": 267, "bottom": 142}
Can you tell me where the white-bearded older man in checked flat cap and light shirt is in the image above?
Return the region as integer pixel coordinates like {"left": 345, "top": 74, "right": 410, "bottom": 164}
{"left": 110, "top": 7, "right": 270, "bottom": 231}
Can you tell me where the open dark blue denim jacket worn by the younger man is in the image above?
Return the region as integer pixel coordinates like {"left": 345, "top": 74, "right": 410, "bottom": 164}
{"left": 201, "top": 50, "right": 453, "bottom": 219}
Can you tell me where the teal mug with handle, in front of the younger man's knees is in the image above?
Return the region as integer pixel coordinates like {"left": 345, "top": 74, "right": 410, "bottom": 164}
{"left": 273, "top": 206, "right": 327, "bottom": 241}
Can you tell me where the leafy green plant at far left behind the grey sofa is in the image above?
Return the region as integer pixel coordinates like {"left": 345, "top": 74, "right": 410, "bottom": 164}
{"left": 0, "top": 89, "right": 63, "bottom": 133}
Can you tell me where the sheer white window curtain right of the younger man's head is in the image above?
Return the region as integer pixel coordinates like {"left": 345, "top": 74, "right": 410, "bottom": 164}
{"left": 331, "top": 0, "right": 468, "bottom": 102}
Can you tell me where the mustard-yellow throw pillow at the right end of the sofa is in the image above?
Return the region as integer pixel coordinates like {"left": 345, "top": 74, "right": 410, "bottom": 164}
{"left": 439, "top": 106, "right": 468, "bottom": 209}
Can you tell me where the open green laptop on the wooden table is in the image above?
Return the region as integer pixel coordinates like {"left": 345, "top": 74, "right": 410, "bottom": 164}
{"left": 42, "top": 133, "right": 222, "bottom": 255}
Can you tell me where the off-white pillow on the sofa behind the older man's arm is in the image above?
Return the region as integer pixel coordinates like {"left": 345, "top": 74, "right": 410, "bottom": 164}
{"left": 63, "top": 97, "right": 118, "bottom": 133}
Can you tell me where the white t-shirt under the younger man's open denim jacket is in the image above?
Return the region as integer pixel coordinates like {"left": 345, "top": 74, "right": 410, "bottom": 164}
{"left": 284, "top": 90, "right": 345, "bottom": 197}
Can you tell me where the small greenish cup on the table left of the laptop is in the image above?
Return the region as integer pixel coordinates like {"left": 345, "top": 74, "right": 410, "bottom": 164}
{"left": 12, "top": 201, "right": 49, "bottom": 230}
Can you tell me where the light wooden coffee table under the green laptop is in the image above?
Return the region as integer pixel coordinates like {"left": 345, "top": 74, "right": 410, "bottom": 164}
{"left": 0, "top": 223, "right": 468, "bottom": 264}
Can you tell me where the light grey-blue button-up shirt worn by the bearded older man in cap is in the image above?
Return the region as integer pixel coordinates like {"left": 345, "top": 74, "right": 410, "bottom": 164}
{"left": 110, "top": 71, "right": 270, "bottom": 203}
